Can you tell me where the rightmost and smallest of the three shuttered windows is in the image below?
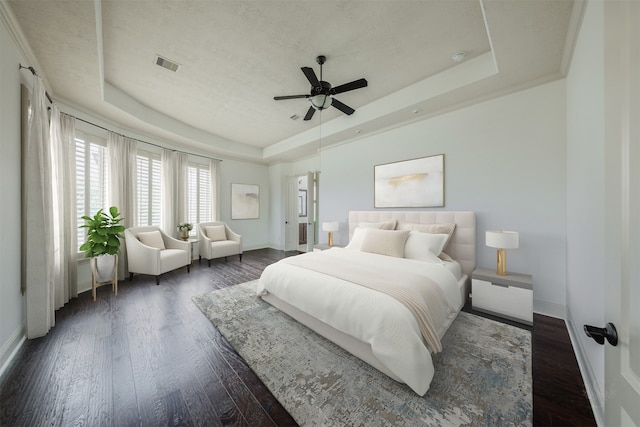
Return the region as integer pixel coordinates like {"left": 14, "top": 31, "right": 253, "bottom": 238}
{"left": 187, "top": 163, "right": 211, "bottom": 224}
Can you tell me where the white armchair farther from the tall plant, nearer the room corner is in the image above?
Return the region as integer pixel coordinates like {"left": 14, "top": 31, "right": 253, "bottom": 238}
{"left": 198, "top": 221, "right": 242, "bottom": 267}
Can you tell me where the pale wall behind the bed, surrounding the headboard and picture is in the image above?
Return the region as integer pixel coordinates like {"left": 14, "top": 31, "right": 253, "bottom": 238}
{"left": 284, "top": 80, "right": 566, "bottom": 317}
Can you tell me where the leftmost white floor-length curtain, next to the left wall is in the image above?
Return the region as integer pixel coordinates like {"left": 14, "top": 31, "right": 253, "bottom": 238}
{"left": 23, "top": 75, "right": 55, "bottom": 338}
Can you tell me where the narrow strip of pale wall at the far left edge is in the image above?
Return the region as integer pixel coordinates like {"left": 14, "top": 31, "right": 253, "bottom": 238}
{"left": 0, "top": 12, "right": 31, "bottom": 373}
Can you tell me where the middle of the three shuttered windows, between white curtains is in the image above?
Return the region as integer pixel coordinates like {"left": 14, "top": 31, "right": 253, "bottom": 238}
{"left": 137, "top": 151, "right": 162, "bottom": 227}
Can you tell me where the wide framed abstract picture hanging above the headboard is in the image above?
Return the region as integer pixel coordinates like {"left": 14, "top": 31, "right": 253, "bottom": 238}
{"left": 373, "top": 154, "right": 444, "bottom": 208}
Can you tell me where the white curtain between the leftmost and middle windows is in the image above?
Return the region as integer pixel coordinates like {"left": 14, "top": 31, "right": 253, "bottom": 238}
{"left": 106, "top": 132, "right": 138, "bottom": 280}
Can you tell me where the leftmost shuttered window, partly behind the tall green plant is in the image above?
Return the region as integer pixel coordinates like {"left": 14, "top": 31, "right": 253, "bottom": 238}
{"left": 76, "top": 133, "right": 108, "bottom": 251}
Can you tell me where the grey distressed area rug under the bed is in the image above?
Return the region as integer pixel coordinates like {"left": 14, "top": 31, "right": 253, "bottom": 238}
{"left": 193, "top": 281, "right": 533, "bottom": 426}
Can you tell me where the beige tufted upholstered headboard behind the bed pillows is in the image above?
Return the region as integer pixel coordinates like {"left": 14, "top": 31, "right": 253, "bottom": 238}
{"left": 349, "top": 211, "right": 476, "bottom": 277}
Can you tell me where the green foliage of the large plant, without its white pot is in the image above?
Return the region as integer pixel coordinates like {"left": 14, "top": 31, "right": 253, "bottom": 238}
{"left": 80, "top": 206, "right": 124, "bottom": 258}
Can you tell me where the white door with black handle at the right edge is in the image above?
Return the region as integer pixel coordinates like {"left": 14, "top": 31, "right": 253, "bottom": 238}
{"left": 604, "top": 0, "right": 640, "bottom": 427}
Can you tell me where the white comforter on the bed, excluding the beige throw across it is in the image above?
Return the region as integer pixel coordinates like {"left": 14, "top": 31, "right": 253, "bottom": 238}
{"left": 257, "top": 248, "right": 461, "bottom": 395}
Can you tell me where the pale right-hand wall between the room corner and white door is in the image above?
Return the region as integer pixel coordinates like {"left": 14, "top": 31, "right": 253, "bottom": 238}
{"left": 567, "top": 1, "right": 607, "bottom": 422}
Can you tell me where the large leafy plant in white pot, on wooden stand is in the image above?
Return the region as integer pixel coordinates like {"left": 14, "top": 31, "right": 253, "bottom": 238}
{"left": 80, "top": 206, "right": 124, "bottom": 283}
